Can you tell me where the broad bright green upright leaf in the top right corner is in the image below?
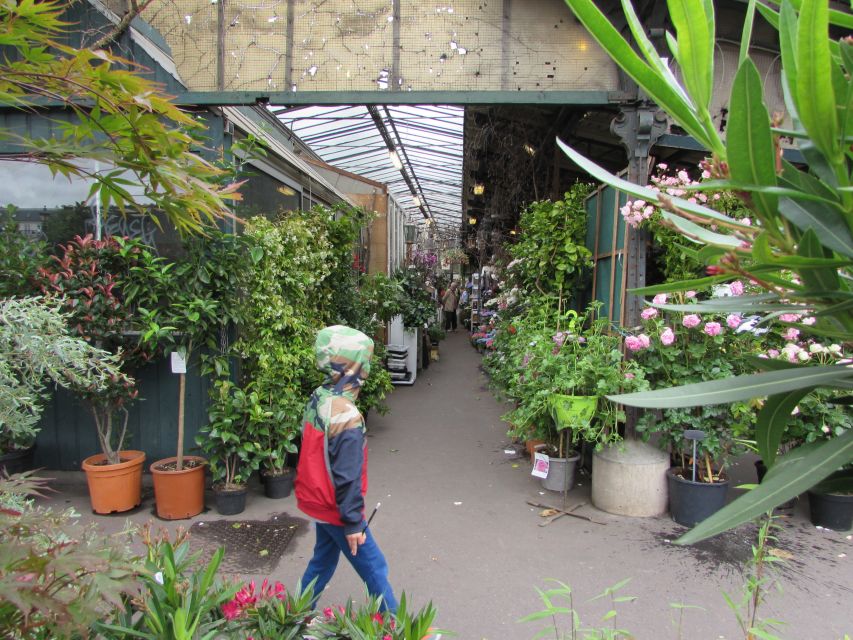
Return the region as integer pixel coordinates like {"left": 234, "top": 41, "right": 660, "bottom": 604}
{"left": 792, "top": 0, "right": 840, "bottom": 162}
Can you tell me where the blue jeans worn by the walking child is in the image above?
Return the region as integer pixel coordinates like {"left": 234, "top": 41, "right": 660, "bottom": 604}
{"left": 302, "top": 522, "right": 397, "bottom": 613}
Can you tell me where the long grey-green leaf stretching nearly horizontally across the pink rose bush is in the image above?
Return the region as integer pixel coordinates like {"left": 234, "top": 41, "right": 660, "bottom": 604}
{"left": 607, "top": 366, "right": 853, "bottom": 409}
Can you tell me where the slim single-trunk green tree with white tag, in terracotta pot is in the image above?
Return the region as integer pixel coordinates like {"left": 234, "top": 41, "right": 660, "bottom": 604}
{"left": 145, "top": 229, "right": 245, "bottom": 520}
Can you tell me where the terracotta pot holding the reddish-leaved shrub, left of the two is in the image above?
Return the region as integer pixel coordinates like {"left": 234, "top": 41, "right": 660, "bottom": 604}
{"left": 82, "top": 451, "right": 145, "bottom": 513}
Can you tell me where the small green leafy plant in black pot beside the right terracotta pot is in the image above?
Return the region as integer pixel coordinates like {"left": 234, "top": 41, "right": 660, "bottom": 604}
{"left": 196, "top": 377, "right": 262, "bottom": 515}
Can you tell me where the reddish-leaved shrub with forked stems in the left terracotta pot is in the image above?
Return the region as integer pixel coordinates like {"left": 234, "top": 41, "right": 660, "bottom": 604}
{"left": 39, "top": 235, "right": 168, "bottom": 513}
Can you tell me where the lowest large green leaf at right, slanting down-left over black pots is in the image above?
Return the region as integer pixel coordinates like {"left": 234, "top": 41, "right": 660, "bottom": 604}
{"left": 675, "top": 429, "right": 853, "bottom": 544}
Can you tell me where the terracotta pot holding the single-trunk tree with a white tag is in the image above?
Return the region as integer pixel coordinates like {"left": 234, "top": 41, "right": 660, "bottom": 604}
{"left": 151, "top": 456, "right": 207, "bottom": 520}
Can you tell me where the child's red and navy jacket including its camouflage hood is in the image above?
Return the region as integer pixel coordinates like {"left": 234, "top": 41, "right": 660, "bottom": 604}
{"left": 295, "top": 326, "right": 373, "bottom": 535}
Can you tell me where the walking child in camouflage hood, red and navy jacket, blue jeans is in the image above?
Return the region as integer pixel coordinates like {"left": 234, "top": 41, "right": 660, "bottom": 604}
{"left": 295, "top": 325, "right": 397, "bottom": 613}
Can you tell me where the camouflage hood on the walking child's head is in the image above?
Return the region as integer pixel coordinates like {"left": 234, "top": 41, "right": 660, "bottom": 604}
{"left": 314, "top": 325, "right": 373, "bottom": 401}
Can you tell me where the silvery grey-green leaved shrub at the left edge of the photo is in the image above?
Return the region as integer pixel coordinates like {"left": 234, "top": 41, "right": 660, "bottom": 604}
{"left": 0, "top": 297, "right": 125, "bottom": 474}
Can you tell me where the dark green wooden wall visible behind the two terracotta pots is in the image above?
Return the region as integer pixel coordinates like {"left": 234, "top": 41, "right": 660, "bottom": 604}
{"left": 35, "top": 359, "right": 209, "bottom": 470}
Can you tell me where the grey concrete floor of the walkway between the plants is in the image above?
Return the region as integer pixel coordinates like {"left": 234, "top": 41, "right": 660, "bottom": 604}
{"left": 35, "top": 332, "right": 853, "bottom": 640}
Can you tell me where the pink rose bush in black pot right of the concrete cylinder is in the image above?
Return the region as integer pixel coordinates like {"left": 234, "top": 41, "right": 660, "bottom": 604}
{"left": 625, "top": 294, "right": 757, "bottom": 527}
